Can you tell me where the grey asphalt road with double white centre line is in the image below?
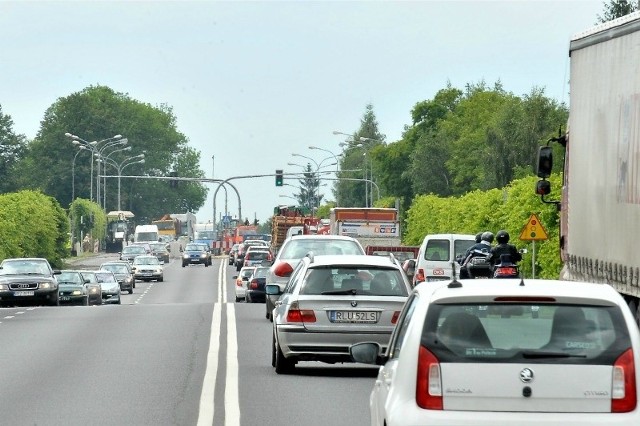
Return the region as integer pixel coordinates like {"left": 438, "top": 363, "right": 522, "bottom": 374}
{"left": 0, "top": 255, "right": 377, "bottom": 426}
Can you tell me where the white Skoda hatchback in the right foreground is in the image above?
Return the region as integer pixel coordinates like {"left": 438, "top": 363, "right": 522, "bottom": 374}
{"left": 350, "top": 279, "right": 640, "bottom": 426}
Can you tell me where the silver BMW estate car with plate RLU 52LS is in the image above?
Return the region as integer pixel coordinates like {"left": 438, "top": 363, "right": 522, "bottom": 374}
{"left": 267, "top": 255, "right": 411, "bottom": 374}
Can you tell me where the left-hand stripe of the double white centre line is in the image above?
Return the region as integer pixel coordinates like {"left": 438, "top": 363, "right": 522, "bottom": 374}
{"left": 197, "top": 303, "right": 222, "bottom": 426}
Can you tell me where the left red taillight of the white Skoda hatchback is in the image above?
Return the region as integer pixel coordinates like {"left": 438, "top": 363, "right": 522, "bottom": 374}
{"left": 416, "top": 346, "right": 442, "bottom": 410}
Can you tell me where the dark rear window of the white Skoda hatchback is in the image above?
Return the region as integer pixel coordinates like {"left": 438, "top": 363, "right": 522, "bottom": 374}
{"left": 422, "top": 303, "right": 631, "bottom": 365}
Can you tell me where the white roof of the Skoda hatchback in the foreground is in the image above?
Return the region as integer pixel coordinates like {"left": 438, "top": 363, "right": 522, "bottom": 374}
{"left": 415, "top": 278, "right": 624, "bottom": 306}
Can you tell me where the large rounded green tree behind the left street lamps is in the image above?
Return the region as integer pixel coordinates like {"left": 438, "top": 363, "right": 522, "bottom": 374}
{"left": 16, "top": 86, "right": 207, "bottom": 223}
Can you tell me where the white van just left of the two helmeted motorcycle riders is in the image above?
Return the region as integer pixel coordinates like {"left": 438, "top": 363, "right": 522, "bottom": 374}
{"left": 413, "top": 234, "right": 476, "bottom": 286}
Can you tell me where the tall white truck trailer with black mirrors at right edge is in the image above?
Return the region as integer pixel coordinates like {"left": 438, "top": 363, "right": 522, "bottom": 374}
{"left": 536, "top": 12, "right": 640, "bottom": 322}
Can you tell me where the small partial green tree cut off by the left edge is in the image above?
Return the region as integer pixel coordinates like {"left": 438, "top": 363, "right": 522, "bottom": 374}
{"left": 0, "top": 105, "right": 26, "bottom": 193}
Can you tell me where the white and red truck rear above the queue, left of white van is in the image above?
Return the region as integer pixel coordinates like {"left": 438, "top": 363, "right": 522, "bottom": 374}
{"left": 329, "top": 207, "right": 401, "bottom": 249}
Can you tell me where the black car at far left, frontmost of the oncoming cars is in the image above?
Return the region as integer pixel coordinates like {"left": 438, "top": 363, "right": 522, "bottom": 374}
{"left": 0, "top": 258, "right": 60, "bottom": 306}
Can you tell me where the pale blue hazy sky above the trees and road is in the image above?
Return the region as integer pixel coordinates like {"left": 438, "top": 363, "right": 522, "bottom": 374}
{"left": 0, "top": 0, "right": 604, "bottom": 222}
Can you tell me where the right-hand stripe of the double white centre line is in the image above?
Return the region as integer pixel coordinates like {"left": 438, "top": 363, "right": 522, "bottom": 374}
{"left": 224, "top": 303, "right": 240, "bottom": 426}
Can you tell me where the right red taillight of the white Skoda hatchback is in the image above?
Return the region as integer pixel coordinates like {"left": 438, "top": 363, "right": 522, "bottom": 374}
{"left": 611, "top": 349, "right": 638, "bottom": 413}
